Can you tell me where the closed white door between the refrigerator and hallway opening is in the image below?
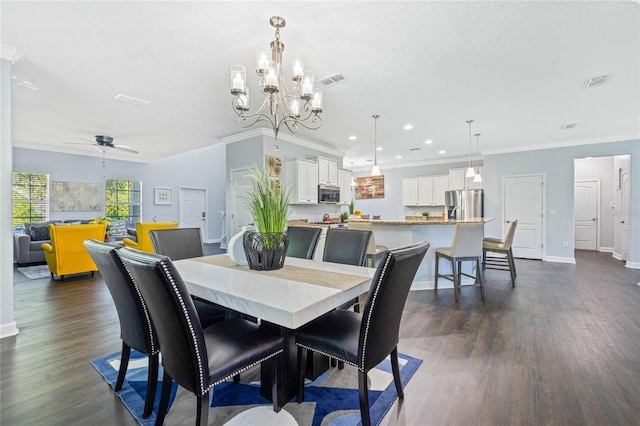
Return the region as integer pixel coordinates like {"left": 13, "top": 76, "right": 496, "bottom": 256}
{"left": 503, "top": 175, "right": 544, "bottom": 259}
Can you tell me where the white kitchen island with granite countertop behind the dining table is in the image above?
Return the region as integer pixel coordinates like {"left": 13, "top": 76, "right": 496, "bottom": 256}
{"left": 347, "top": 217, "right": 494, "bottom": 290}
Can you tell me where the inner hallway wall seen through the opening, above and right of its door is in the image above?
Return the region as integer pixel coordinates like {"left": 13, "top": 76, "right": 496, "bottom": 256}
{"left": 574, "top": 157, "right": 615, "bottom": 250}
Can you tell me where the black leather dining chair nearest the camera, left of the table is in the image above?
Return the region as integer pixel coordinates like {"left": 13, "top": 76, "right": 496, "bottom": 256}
{"left": 117, "top": 248, "right": 283, "bottom": 425}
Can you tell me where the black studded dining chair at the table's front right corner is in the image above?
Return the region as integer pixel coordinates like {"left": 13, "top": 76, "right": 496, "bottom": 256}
{"left": 295, "top": 241, "right": 429, "bottom": 426}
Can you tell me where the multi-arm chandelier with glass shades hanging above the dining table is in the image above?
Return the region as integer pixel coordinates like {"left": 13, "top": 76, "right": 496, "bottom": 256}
{"left": 231, "top": 16, "right": 322, "bottom": 140}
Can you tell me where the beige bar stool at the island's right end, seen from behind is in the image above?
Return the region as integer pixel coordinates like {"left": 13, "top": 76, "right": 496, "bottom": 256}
{"left": 435, "top": 223, "right": 484, "bottom": 302}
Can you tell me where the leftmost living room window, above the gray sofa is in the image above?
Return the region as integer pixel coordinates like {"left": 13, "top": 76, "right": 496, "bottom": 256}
{"left": 11, "top": 172, "right": 49, "bottom": 228}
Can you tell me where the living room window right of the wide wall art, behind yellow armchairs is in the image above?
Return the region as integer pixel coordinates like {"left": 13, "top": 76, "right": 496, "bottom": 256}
{"left": 105, "top": 179, "right": 142, "bottom": 226}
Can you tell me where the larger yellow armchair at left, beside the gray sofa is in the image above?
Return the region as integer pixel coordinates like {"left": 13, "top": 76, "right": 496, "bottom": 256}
{"left": 41, "top": 224, "right": 107, "bottom": 280}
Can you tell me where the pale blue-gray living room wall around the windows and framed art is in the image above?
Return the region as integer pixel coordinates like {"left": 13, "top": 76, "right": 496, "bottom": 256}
{"left": 13, "top": 144, "right": 225, "bottom": 241}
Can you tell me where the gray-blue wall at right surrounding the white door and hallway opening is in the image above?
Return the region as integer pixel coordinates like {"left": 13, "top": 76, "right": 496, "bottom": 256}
{"left": 483, "top": 140, "right": 640, "bottom": 267}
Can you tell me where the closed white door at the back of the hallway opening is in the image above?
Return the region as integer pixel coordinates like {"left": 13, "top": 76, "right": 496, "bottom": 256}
{"left": 573, "top": 180, "right": 600, "bottom": 251}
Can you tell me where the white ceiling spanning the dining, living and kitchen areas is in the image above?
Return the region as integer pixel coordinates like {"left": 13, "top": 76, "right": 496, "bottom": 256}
{"left": 0, "top": 1, "right": 640, "bottom": 168}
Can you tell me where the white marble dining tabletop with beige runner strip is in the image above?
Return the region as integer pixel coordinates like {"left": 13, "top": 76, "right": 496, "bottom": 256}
{"left": 174, "top": 254, "right": 375, "bottom": 329}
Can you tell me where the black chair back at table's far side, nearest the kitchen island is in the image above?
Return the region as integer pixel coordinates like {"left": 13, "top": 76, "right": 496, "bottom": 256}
{"left": 322, "top": 228, "right": 371, "bottom": 266}
